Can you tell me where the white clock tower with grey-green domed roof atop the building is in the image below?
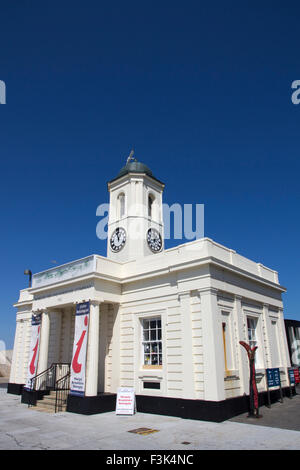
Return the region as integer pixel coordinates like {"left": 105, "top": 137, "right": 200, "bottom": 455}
{"left": 107, "top": 152, "right": 165, "bottom": 262}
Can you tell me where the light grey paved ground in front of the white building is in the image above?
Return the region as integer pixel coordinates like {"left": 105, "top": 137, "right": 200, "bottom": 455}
{"left": 0, "top": 388, "right": 300, "bottom": 451}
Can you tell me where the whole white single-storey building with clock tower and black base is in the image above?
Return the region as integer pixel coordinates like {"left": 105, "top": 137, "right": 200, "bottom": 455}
{"left": 8, "top": 161, "right": 290, "bottom": 421}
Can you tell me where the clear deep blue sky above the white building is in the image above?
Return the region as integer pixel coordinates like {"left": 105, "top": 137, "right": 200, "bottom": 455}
{"left": 0, "top": 0, "right": 300, "bottom": 348}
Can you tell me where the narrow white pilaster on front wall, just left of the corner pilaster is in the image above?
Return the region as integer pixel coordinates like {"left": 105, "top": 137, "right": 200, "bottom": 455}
{"left": 178, "top": 292, "right": 195, "bottom": 399}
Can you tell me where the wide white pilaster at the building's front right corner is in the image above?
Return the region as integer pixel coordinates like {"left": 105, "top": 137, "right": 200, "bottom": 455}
{"left": 199, "top": 288, "right": 225, "bottom": 401}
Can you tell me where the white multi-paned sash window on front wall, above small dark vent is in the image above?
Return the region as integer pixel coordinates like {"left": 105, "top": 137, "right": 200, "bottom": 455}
{"left": 142, "top": 317, "right": 162, "bottom": 368}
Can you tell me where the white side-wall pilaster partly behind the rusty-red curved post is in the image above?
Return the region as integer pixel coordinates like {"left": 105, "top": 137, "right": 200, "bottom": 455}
{"left": 234, "top": 295, "right": 249, "bottom": 394}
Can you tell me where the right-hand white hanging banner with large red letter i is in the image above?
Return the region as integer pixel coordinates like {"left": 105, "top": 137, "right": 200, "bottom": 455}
{"left": 70, "top": 302, "right": 90, "bottom": 397}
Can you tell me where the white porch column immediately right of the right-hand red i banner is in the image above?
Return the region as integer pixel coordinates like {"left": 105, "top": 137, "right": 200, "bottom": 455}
{"left": 85, "top": 300, "right": 100, "bottom": 397}
